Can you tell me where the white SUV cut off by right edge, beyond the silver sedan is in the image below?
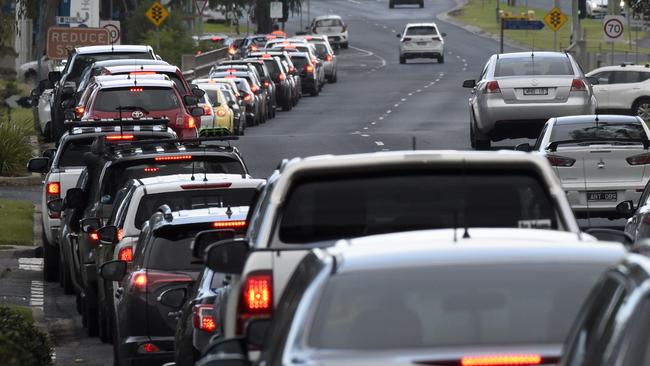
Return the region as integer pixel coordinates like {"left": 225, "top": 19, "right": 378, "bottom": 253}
{"left": 587, "top": 64, "right": 650, "bottom": 122}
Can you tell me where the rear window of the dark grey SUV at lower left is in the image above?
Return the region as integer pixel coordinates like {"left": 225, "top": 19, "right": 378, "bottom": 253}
{"left": 147, "top": 224, "right": 210, "bottom": 272}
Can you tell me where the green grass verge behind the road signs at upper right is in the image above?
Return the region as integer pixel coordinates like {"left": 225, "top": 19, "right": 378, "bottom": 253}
{"left": 449, "top": 0, "right": 650, "bottom": 53}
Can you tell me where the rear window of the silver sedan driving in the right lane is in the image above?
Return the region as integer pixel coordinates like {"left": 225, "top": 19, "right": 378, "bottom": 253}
{"left": 494, "top": 55, "right": 573, "bottom": 77}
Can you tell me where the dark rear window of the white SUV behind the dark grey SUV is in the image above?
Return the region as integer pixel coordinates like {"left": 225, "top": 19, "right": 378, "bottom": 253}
{"left": 135, "top": 188, "right": 256, "bottom": 229}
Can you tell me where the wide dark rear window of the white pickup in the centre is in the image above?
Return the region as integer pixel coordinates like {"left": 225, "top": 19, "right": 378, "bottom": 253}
{"left": 279, "top": 170, "right": 557, "bottom": 244}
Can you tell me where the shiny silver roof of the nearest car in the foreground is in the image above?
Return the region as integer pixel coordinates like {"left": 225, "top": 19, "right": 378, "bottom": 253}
{"left": 326, "top": 228, "right": 627, "bottom": 273}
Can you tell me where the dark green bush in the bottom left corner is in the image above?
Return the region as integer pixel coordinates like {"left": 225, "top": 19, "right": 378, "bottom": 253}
{"left": 0, "top": 306, "right": 53, "bottom": 366}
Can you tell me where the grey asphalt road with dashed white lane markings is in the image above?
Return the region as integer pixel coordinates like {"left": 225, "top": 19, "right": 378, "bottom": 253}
{"left": 0, "top": 0, "right": 624, "bottom": 365}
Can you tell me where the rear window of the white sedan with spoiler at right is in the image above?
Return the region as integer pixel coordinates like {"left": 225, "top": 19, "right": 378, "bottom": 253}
{"left": 551, "top": 122, "right": 648, "bottom": 141}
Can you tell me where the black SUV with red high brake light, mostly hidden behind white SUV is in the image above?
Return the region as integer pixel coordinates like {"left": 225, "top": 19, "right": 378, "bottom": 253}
{"left": 51, "top": 138, "right": 248, "bottom": 341}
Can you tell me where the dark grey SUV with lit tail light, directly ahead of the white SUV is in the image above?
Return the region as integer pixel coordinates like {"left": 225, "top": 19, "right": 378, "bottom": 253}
{"left": 99, "top": 206, "right": 248, "bottom": 366}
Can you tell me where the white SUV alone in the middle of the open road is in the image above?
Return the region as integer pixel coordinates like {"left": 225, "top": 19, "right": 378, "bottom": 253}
{"left": 397, "top": 23, "right": 446, "bottom": 64}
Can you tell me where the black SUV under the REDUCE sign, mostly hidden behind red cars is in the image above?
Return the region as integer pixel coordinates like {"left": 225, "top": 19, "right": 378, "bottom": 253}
{"left": 48, "top": 45, "right": 158, "bottom": 141}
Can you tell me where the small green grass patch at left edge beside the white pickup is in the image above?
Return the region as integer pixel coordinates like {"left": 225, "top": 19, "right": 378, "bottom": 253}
{"left": 0, "top": 199, "right": 34, "bottom": 245}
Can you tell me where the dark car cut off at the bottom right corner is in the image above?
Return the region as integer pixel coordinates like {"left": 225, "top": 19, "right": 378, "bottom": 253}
{"left": 560, "top": 245, "right": 650, "bottom": 366}
